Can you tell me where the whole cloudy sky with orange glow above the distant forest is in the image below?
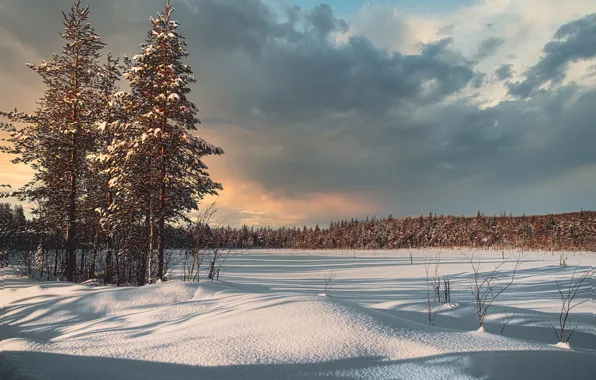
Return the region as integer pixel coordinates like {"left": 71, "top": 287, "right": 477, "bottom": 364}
{"left": 0, "top": 0, "right": 596, "bottom": 226}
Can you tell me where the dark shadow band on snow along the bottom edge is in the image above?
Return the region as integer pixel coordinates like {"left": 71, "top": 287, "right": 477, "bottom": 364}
{"left": 0, "top": 350, "right": 596, "bottom": 380}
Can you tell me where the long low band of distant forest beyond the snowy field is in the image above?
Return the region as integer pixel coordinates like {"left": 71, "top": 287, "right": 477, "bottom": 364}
{"left": 183, "top": 211, "right": 596, "bottom": 251}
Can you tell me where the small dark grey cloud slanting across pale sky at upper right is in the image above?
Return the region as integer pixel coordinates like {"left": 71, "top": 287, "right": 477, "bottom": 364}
{"left": 508, "top": 13, "right": 596, "bottom": 98}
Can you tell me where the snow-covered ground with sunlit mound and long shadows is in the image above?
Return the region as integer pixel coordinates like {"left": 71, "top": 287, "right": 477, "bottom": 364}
{"left": 0, "top": 251, "right": 596, "bottom": 380}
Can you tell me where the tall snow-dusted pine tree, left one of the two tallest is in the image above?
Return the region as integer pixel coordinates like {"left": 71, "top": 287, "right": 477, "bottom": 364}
{"left": 3, "top": 0, "right": 104, "bottom": 281}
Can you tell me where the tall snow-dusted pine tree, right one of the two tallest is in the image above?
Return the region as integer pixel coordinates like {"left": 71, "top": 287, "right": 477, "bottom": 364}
{"left": 118, "top": 1, "right": 223, "bottom": 279}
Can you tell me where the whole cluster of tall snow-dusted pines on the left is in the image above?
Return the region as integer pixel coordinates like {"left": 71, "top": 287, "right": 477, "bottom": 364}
{"left": 0, "top": 0, "right": 223, "bottom": 284}
